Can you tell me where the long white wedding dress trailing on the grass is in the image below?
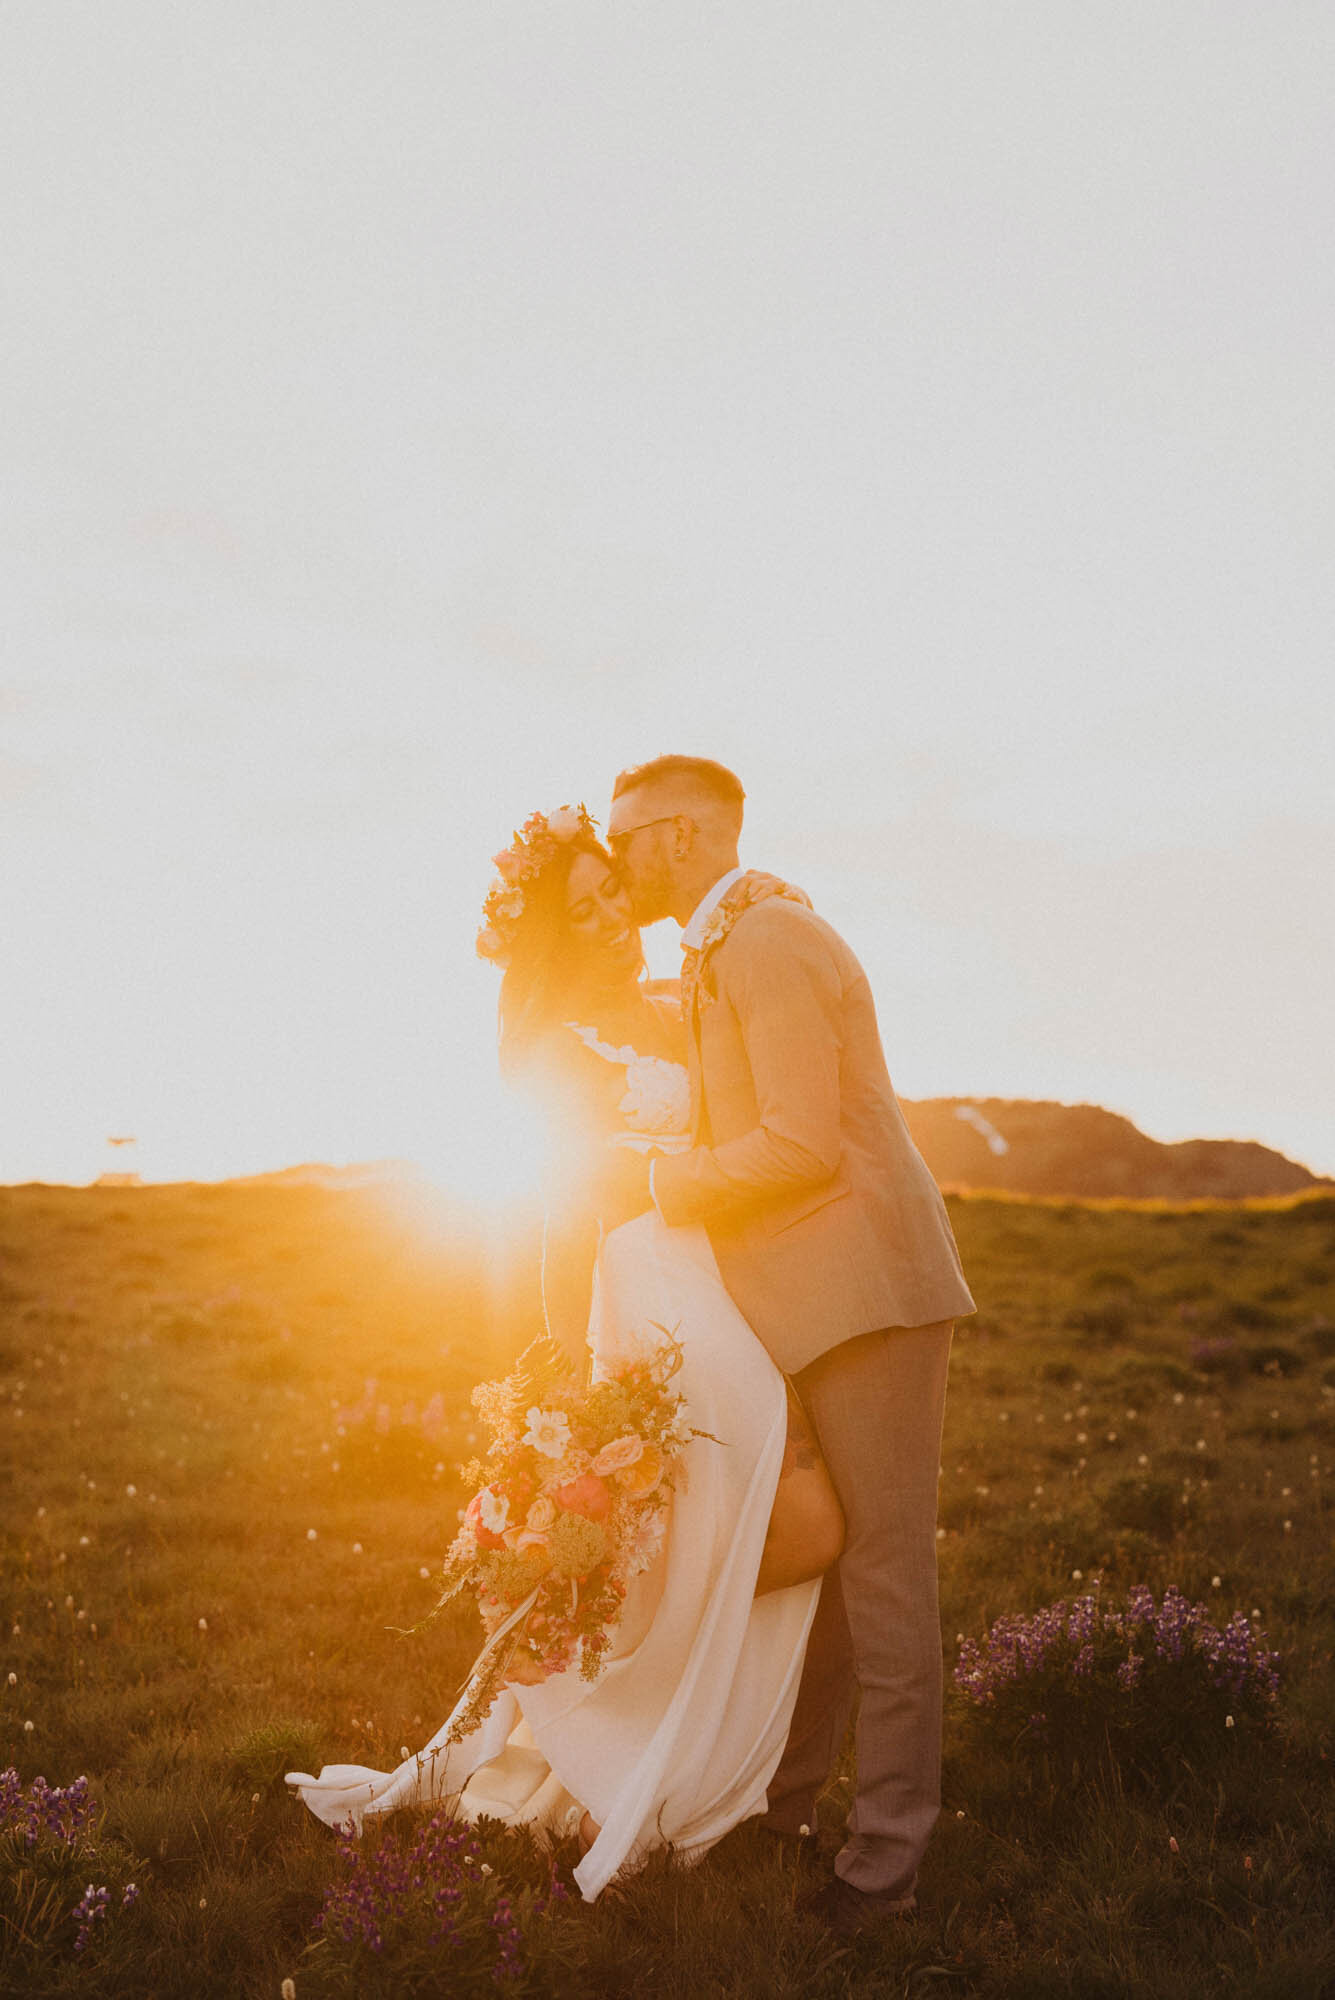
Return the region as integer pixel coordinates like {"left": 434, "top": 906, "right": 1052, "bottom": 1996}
{"left": 288, "top": 1022, "right": 819, "bottom": 1902}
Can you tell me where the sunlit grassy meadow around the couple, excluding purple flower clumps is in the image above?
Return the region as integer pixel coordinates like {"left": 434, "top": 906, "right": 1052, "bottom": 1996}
{"left": 0, "top": 1186, "right": 1335, "bottom": 2000}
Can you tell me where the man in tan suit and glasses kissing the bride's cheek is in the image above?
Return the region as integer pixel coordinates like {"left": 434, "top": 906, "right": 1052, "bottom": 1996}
{"left": 608, "top": 756, "right": 973, "bottom": 1936}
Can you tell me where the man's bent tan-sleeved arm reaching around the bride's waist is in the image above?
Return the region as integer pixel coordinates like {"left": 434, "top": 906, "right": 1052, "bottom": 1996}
{"left": 654, "top": 898, "right": 843, "bottom": 1224}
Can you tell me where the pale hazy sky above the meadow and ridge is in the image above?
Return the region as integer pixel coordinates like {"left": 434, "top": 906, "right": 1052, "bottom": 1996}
{"left": 0, "top": 0, "right": 1335, "bottom": 1184}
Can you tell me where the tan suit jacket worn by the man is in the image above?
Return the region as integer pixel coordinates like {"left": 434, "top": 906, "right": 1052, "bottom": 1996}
{"left": 654, "top": 880, "right": 975, "bottom": 1374}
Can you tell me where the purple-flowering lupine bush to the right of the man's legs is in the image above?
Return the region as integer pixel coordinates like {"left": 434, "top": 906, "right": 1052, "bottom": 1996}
{"left": 955, "top": 1584, "right": 1279, "bottom": 1780}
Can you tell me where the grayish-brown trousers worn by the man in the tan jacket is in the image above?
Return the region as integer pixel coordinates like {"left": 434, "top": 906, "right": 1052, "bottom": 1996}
{"left": 765, "top": 1320, "right": 953, "bottom": 1902}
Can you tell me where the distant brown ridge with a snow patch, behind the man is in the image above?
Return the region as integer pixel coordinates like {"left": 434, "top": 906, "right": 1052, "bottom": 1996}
{"left": 901, "top": 1098, "right": 1331, "bottom": 1202}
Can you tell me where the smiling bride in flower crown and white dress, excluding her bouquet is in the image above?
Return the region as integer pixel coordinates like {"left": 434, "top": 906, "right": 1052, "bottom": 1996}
{"left": 288, "top": 806, "right": 843, "bottom": 1902}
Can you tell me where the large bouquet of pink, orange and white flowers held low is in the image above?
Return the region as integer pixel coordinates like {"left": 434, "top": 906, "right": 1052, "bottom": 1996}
{"left": 438, "top": 1328, "right": 705, "bottom": 1742}
